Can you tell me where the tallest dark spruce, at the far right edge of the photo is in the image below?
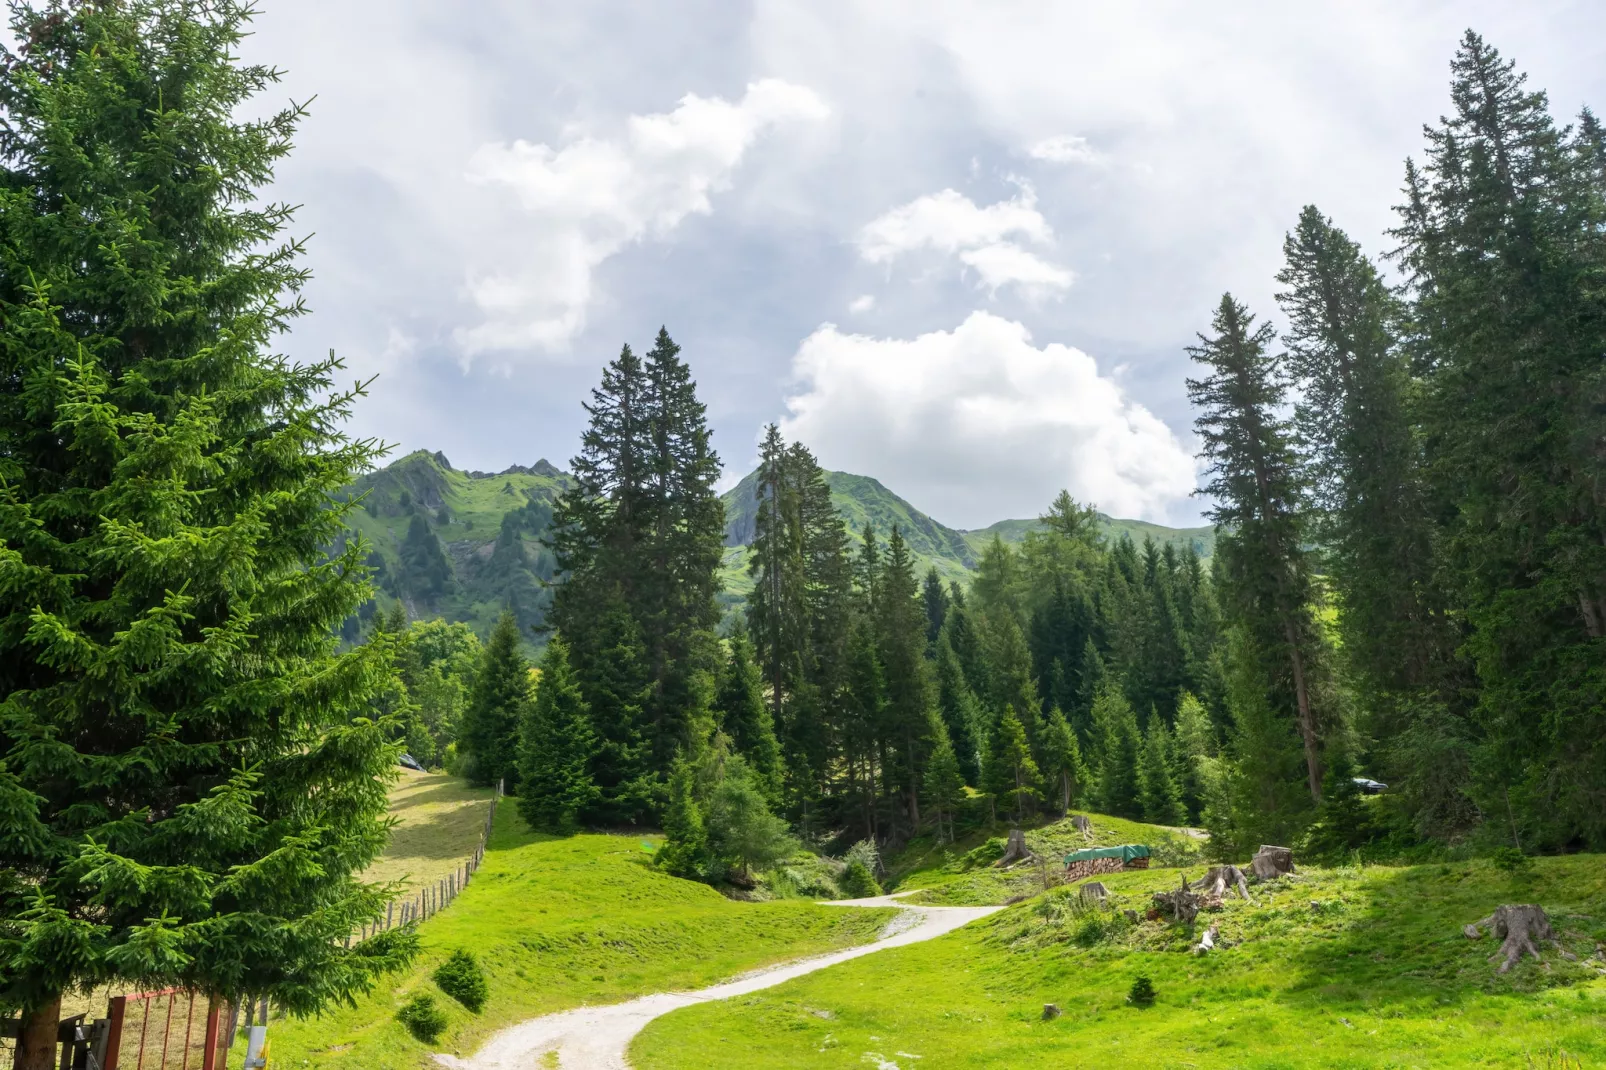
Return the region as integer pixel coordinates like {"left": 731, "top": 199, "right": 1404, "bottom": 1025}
{"left": 1396, "top": 32, "right": 1606, "bottom": 847}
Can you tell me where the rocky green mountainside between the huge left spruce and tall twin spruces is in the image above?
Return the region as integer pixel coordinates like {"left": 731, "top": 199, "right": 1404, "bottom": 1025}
{"left": 338, "top": 450, "right": 570, "bottom": 638}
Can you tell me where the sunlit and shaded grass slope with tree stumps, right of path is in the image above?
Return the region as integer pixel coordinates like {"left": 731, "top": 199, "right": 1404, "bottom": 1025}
{"left": 633, "top": 816, "right": 1606, "bottom": 1070}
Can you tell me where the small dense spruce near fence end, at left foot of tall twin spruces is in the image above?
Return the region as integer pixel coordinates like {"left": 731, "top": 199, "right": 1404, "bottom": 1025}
{"left": 519, "top": 636, "right": 601, "bottom": 832}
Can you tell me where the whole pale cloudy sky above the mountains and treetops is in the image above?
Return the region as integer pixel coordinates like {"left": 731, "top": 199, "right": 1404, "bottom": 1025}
{"left": 237, "top": 0, "right": 1606, "bottom": 527}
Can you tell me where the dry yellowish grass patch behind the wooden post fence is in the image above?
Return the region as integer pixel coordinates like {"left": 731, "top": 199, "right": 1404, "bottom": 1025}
{"left": 363, "top": 770, "right": 491, "bottom": 888}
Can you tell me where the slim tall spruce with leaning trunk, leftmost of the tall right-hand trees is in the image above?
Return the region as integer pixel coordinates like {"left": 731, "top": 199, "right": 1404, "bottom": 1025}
{"left": 1188, "top": 294, "right": 1323, "bottom": 800}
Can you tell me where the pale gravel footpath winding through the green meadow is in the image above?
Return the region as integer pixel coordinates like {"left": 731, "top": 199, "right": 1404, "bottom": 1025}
{"left": 435, "top": 893, "right": 1004, "bottom": 1070}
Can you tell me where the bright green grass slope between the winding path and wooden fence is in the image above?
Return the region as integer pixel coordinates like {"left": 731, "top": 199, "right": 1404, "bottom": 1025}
{"left": 273, "top": 800, "right": 890, "bottom": 1070}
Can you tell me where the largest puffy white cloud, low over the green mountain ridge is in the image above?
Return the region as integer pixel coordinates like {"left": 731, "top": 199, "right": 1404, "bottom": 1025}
{"left": 781, "top": 312, "right": 1196, "bottom": 527}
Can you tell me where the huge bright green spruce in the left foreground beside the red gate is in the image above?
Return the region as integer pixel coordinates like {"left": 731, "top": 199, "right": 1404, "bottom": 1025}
{"left": 0, "top": 0, "right": 416, "bottom": 1070}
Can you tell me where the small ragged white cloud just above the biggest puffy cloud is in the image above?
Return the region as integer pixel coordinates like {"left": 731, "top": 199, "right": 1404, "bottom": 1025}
{"left": 859, "top": 185, "right": 1074, "bottom": 297}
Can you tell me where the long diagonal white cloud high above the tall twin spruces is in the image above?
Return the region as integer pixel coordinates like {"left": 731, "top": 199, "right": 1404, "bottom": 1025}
{"left": 456, "top": 79, "right": 830, "bottom": 357}
